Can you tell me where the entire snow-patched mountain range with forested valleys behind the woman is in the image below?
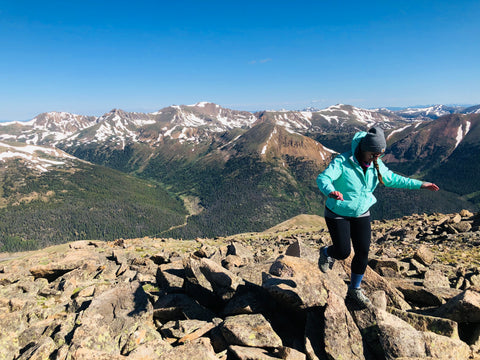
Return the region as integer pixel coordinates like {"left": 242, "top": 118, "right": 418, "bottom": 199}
{"left": 0, "top": 102, "right": 480, "bottom": 249}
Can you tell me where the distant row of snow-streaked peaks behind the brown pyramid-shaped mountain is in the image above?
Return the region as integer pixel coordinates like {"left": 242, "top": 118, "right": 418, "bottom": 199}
{"left": 0, "top": 102, "right": 414, "bottom": 148}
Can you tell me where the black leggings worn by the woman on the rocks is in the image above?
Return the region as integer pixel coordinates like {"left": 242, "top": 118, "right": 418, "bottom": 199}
{"left": 325, "top": 212, "right": 372, "bottom": 275}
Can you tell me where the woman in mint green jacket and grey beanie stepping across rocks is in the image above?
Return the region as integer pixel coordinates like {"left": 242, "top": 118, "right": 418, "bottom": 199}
{"left": 317, "top": 127, "right": 439, "bottom": 306}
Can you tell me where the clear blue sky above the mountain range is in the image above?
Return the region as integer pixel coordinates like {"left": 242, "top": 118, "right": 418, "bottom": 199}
{"left": 0, "top": 0, "right": 480, "bottom": 120}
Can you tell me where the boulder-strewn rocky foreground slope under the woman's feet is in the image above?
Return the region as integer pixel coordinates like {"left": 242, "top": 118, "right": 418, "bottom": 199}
{"left": 0, "top": 211, "right": 480, "bottom": 360}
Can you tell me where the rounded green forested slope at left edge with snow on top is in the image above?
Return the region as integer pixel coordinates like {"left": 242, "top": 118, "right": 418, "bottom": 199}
{"left": 0, "top": 144, "right": 187, "bottom": 251}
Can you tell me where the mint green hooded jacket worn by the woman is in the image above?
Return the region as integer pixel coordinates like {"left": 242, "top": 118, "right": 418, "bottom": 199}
{"left": 317, "top": 131, "right": 422, "bottom": 217}
